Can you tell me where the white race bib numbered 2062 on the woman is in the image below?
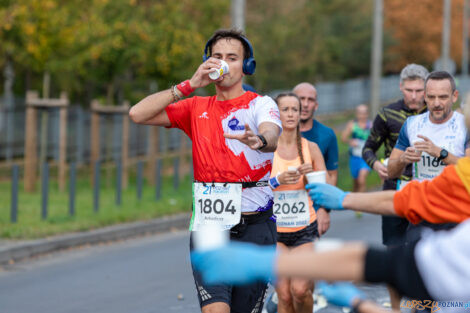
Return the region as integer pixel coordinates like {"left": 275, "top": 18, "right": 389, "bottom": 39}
{"left": 274, "top": 190, "right": 310, "bottom": 227}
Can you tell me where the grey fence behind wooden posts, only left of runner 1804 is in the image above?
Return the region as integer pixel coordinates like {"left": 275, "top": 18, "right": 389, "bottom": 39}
{"left": 0, "top": 103, "right": 190, "bottom": 165}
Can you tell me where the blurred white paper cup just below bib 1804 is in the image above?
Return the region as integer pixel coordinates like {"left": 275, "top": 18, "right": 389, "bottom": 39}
{"left": 193, "top": 225, "right": 229, "bottom": 251}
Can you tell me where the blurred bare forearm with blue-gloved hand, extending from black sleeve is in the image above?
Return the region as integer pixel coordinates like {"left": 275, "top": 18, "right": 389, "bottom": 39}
{"left": 191, "top": 242, "right": 367, "bottom": 284}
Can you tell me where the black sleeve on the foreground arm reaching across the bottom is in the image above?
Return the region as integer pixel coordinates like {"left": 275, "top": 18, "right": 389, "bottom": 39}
{"left": 364, "top": 241, "right": 433, "bottom": 300}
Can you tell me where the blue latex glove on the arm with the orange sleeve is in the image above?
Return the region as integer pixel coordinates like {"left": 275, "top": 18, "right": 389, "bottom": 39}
{"left": 305, "top": 183, "right": 349, "bottom": 210}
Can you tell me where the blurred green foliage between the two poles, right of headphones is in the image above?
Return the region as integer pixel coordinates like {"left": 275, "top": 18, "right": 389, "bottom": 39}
{"left": 247, "top": 0, "right": 372, "bottom": 89}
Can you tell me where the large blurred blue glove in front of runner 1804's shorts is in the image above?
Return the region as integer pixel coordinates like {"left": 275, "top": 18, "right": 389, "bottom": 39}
{"left": 191, "top": 242, "right": 276, "bottom": 285}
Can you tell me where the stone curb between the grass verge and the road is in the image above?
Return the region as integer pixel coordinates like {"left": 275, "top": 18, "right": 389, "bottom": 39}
{"left": 0, "top": 213, "right": 190, "bottom": 265}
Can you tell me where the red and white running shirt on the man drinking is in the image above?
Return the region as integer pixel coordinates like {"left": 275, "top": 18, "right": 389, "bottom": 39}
{"left": 165, "top": 91, "right": 282, "bottom": 212}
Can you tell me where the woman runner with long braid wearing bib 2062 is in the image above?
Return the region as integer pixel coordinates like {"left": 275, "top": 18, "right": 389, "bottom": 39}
{"left": 270, "top": 93, "right": 326, "bottom": 313}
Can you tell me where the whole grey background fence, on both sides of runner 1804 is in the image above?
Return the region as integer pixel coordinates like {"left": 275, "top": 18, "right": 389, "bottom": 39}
{"left": 0, "top": 75, "right": 470, "bottom": 165}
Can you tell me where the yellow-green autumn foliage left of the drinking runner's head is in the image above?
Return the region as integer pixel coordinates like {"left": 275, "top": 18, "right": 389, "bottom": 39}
{"left": 0, "top": 0, "right": 229, "bottom": 103}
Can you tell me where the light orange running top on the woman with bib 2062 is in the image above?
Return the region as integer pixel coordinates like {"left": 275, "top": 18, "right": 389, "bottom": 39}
{"left": 271, "top": 138, "right": 317, "bottom": 233}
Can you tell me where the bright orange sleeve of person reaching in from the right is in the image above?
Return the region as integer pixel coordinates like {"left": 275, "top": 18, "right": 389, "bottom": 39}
{"left": 393, "top": 162, "right": 470, "bottom": 224}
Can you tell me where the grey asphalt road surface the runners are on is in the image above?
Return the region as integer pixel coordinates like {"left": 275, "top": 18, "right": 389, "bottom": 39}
{"left": 0, "top": 212, "right": 388, "bottom": 313}
